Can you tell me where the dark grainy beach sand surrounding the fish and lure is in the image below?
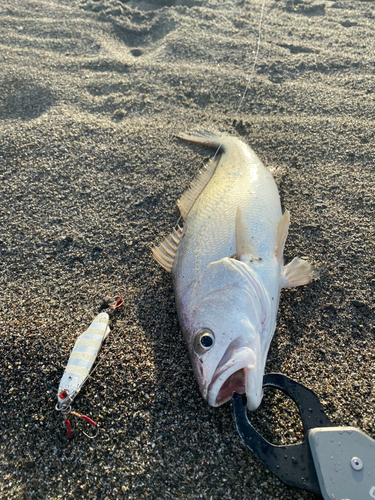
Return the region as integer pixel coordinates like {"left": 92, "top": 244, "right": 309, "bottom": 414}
{"left": 0, "top": 0, "right": 375, "bottom": 500}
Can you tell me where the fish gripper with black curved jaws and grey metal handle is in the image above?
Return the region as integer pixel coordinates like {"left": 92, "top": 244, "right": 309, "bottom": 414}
{"left": 233, "top": 373, "right": 375, "bottom": 500}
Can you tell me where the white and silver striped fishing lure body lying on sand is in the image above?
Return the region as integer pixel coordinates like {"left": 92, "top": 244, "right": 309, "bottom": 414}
{"left": 57, "top": 312, "right": 110, "bottom": 410}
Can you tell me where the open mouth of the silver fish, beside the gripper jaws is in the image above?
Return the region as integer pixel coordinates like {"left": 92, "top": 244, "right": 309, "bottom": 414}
{"left": 207, "top": 346, "right": 263, "bottom": 411}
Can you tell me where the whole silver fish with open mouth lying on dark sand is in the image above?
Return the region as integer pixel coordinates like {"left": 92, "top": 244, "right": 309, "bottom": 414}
{"left": 152, "top": 129, "right": 318, "bottom": 411}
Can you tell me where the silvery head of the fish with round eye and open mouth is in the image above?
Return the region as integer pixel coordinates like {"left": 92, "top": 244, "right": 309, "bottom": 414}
{"left": 180, "top": 259, "right": 269, "bottom": 410}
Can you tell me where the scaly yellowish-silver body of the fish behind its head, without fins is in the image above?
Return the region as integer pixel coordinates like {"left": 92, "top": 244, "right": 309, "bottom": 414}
{"left": 172, "top": 131, "right": 281, "bottom": 298}
